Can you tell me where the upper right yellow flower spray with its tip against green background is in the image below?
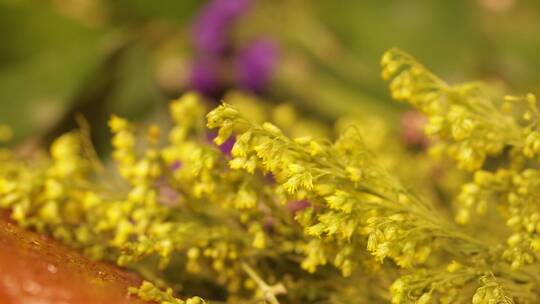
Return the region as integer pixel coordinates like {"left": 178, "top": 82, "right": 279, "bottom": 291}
{"left": 381, "top": 49, "right": 522, "bottom": 171}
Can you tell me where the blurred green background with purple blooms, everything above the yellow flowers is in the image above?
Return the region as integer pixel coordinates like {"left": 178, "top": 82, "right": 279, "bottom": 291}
{"left": 0, "top": 0, "right": 540, "bottom": 153}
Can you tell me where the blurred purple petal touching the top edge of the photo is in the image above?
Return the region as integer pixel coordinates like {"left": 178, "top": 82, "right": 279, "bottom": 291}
{"left": 193, "top": 0, "right": 249, "bottom": 55}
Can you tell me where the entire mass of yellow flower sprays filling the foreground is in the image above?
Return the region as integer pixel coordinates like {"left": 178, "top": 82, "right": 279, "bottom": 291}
{"left": 5, "top": 49, "right": 540, "bottom": 304}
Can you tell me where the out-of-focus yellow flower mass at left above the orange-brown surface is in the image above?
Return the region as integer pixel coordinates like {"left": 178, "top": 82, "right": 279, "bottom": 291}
{"left": 0, "top": 93, "right": 392, "bottom": 303}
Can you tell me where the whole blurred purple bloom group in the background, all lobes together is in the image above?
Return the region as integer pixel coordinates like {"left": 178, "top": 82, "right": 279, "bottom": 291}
{"left": 189, "top": 0, "right": 278, "bottom": 99}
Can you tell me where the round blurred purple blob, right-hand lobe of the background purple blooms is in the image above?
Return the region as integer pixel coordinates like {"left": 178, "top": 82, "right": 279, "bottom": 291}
{"left": 236, "top": 39, "right": 278, "bottom": 92}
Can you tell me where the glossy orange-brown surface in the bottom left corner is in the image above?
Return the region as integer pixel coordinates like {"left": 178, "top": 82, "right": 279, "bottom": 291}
{"left": 0, "top": 211, "right": 151, "bottom": 304}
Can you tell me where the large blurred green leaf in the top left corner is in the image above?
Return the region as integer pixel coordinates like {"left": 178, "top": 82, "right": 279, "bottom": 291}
{"left": 0, "top": 2, "right": 104, "bottom": 142}
